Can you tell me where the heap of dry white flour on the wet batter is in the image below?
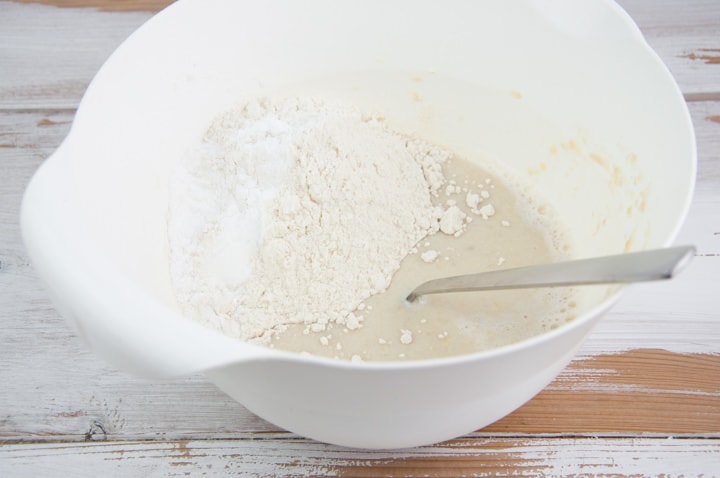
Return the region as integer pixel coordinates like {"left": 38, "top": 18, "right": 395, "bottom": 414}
{"left": 168, "top": 99, "right": 452, "bottom": 342}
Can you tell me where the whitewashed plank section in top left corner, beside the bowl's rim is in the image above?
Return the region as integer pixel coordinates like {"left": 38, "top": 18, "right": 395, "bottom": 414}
{"left": 0, "top": 1, "right": 151, "bottom": 109}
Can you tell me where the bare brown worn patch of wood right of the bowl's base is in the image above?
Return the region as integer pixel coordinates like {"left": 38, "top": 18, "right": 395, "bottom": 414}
{"left": 490, "top": 349, "right": 720, "bottom": 436}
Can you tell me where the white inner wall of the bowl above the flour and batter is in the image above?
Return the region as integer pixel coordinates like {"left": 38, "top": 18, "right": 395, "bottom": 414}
{"left": 31, "top": 0, "right": 695, "bottom": 348}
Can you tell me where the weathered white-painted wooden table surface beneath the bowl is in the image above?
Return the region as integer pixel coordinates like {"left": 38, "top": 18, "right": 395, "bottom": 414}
{"left": 0, "top": 0, "right": 720, "bottom": 477}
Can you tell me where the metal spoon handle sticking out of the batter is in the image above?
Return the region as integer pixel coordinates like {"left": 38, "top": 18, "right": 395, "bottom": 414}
{"left": 406, "top": 246, "right": 695, "bottom": 302}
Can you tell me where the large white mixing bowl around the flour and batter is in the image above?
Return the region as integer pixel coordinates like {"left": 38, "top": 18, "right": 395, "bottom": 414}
{"left": 22, "top": 0, "right": 696, "bottom": 448}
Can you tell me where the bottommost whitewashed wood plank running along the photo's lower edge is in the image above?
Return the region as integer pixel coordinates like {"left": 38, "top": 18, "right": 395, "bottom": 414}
{"left": 0, "top": 434, "right": 720, "bottom": 478}
